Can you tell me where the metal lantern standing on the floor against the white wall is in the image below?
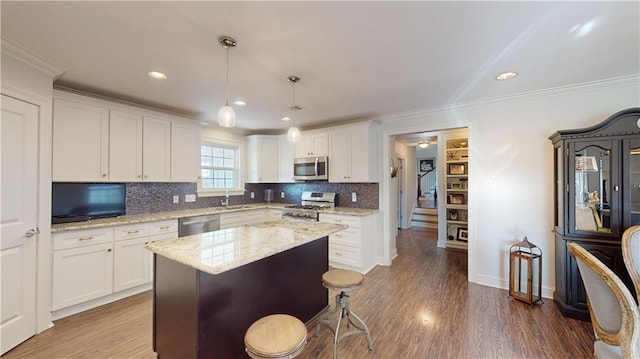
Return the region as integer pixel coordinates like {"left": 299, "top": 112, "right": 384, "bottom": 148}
{"left": 509, "top": 237, "right": 542, "bottom": 305}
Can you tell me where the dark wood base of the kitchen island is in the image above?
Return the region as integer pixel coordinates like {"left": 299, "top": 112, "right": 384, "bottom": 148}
{"left": 153, "top": 236, "right": 329, "bottom": 359}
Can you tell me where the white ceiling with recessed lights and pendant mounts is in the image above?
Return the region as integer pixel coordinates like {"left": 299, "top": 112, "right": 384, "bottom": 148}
{"left": 1, "top": 1, "right": 640, "bottom": 132}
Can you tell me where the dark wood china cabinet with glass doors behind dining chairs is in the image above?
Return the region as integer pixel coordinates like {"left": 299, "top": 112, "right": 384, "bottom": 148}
{"left": 549, "top": 108, "right": 640, "bottom": 320}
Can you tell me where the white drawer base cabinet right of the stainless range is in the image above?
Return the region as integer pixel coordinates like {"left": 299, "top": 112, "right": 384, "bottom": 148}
{"left": 320, "top": 212, "right": 377, "bottom": 273}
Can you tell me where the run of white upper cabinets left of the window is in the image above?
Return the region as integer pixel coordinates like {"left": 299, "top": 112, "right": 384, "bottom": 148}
{"left": 52, "top": 91, "right": 201, "bottom": 183}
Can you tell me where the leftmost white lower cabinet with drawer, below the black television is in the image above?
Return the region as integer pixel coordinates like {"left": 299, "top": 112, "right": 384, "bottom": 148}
{"left": 51, "top": 228, "right": 113, "bottom": 310}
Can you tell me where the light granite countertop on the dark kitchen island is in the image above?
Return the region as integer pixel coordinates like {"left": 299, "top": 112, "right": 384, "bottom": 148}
{"left": 146, "top": 220, "right": 347, "bottom": 275}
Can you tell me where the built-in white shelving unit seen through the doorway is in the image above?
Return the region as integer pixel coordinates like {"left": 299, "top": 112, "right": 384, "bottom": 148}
{"left": 445, "top": 138, "right": 469, "bottom": 249}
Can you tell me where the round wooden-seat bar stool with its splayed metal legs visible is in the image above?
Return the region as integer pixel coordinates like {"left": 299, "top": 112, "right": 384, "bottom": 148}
{"left": 315, "top": 269, "right": 373, "bottom": 359}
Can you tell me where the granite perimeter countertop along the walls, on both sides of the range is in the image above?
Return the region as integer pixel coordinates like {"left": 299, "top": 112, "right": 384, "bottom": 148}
{"left": 51, "top": 203, "right": 379, "bottom": 233}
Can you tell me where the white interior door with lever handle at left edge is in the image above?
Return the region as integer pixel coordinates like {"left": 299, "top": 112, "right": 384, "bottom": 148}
{"left": 0, "top": 95, "right": 39, "bottom": 354}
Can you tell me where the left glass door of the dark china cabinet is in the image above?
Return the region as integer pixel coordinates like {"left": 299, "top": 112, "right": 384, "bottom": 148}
{"left": 570, "top": 142, "right": 615, "bottom": 233}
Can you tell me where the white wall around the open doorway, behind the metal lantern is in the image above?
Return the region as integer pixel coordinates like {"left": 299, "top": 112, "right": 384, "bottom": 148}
{"left": 380, "top": 76, "right": 640, "bottom": 297}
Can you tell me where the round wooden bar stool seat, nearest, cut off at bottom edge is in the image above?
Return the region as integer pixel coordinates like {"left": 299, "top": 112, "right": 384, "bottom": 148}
{"left": 244, "top": 314, "right": 307, "bottom": 359}
